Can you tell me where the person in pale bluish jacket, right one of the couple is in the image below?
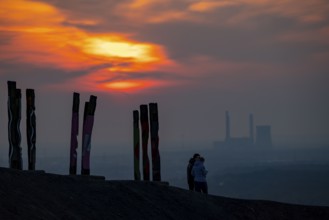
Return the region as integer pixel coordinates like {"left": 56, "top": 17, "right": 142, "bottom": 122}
{"left": 191, "top": 157, "right": 208, "bottom": 194}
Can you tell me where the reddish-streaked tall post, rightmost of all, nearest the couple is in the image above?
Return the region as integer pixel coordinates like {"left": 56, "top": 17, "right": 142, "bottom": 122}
{"left": 149, "top": 103, "right": 161, "bottom": 181}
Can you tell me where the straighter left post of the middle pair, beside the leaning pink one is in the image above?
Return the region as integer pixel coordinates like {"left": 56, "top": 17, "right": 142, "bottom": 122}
{"left": 70, "top": 92, "right": 80, "bottom": 175}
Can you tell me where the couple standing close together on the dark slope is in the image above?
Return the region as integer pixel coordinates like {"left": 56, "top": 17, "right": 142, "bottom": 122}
{"left": 187, "top": 154, "right": 208, "bottom": 194}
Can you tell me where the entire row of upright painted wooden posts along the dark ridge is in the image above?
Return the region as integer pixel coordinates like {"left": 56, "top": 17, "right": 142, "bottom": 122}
{"left": 7, "top": 81, "right": 161, "bottom": 181}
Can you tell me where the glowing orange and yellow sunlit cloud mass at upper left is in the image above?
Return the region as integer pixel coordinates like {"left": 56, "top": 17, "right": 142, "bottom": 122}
{"left": 0, "top": 0, "right": 172, "bottom": 90}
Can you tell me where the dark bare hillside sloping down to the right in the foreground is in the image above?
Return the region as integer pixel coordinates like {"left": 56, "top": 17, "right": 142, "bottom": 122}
{"left": 0, "top": 168, "right": 329, "bottom": 220}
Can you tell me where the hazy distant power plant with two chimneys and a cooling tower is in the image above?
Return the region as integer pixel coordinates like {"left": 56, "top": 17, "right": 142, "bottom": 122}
{"left": 214, "top": 111, "right": 272, "bottom": 148}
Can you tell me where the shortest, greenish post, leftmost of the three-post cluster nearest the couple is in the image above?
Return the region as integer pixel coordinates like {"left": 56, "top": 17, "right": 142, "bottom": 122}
{"left": 133, "top": 110, "right": 141, "bottom": 180}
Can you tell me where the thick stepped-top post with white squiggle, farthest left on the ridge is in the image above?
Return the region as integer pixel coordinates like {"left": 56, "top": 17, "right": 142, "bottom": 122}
{"left": 7, "top": 81, "right": 23, "bottom": 170}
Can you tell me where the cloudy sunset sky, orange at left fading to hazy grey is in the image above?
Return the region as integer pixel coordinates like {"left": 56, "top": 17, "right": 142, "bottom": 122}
{"left": 0, "top": 0, "right": 329, "bottom": 155}
